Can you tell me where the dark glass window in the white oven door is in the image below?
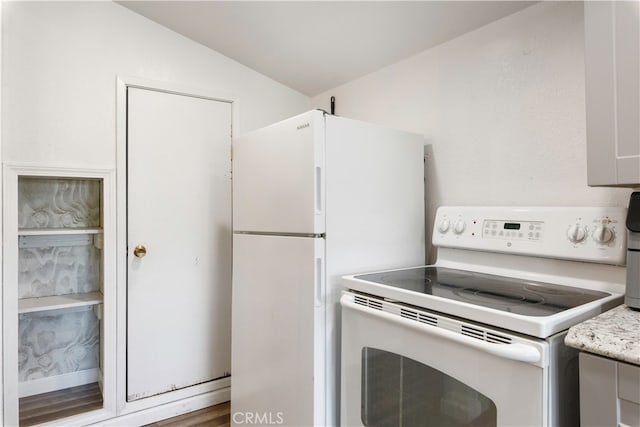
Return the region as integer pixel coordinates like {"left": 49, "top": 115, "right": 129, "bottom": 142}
{"left": 361, "top": 347, "right": 497, "bottom": 427}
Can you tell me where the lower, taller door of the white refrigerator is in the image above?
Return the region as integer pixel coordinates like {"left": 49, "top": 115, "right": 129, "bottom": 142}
{"left": 231, "top": 234, "right": 326, "bottom": 426}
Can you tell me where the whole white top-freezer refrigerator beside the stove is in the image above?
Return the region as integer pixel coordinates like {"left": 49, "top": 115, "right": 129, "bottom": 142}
{"left": 231, "top": 110, "right": 425, "bottom": 426}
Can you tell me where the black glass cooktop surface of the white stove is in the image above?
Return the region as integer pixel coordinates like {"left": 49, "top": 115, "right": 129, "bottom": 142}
{"left": 354, "top": 266, "right": 610, "bottom": 316}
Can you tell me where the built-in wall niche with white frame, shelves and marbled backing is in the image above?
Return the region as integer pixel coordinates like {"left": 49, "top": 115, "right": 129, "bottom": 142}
{"left": 3, "top": 167, "right": 115, "bottom": 426}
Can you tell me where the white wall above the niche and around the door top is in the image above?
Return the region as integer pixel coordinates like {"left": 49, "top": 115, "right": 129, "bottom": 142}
{"left": 2, "top": 1, "right": 309, "bottom": 167}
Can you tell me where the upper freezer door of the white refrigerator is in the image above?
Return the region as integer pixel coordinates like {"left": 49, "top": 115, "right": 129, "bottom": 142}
{"left": 233, "top": 110, "right": 324, "bottom": 234}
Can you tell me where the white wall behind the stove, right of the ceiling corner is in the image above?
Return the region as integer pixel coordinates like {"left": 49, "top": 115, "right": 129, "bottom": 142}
{"left": 312, "top": 2, "right": 630, "bottom": 232}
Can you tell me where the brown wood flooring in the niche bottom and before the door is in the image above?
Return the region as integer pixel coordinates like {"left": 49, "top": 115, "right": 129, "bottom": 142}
{"left": 20, "top": 383, "right": 231, "bottom": 427}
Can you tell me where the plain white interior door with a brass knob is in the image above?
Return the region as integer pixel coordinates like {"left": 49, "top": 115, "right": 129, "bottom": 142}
{"left": 127, "top": 88, "right": 231, "bottom": 401}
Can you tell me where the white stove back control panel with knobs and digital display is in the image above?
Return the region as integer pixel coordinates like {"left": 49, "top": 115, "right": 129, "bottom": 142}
{"left": 433, "top": 206, "right": 627, "bottom": 265}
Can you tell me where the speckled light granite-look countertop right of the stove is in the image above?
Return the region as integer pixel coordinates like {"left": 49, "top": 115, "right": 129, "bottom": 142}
{"left": 564, "top": 305, "right": 640, "bottom": 365}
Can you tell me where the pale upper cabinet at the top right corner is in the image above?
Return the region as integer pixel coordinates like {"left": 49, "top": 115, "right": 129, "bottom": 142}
{"left": 584, "top": 1, "right": 640, "bottom": 186}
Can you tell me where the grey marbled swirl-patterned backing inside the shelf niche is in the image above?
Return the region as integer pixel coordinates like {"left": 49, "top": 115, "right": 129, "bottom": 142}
{"left": 17, "top": 176, "right": 103, "bottom": 389}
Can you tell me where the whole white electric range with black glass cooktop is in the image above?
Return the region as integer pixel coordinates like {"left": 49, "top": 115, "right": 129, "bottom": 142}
{"left": 341, "top": 207, "right": 626, "bottom": 427}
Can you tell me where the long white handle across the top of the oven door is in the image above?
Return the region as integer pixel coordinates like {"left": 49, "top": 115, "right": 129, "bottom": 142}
{"left": 340, "top": 295, "right": 541, "bottom": 363}
